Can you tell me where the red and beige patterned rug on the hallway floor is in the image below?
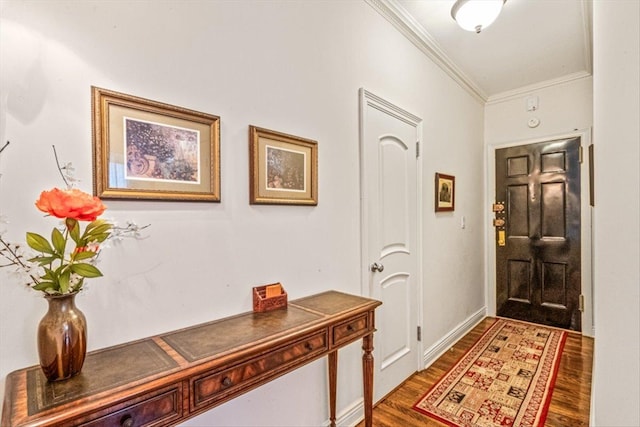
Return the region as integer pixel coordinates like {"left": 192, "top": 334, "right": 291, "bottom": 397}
{"left": 413, "top": 319, "right": 567, "bottom": 427}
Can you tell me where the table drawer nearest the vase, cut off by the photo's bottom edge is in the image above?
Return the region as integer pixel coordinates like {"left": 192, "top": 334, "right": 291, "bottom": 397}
{"left": 80, "top": 384, "right": 182, "bottom": 427}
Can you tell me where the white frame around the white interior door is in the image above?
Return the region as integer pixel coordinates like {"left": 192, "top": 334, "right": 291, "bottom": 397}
{"left": 358, "top": 88, "right": 424, "bottom": 372}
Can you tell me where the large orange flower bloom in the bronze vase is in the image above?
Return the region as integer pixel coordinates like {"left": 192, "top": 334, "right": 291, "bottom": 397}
{"left": 36, "top": 188, "right": 107, "bottom": 221}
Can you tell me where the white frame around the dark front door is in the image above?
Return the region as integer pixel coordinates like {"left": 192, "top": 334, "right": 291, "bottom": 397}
{"left": 484, "top": 128, "right": 595, "bottom": 337}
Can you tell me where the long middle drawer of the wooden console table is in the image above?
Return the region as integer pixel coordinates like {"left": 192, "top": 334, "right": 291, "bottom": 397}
{"left": 191, "top": 331, "right": 328, "bottom": 409}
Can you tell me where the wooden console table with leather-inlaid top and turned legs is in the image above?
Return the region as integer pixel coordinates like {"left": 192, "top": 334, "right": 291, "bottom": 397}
{"left": 2, "top": 291, "right": 381, "bottom": 427}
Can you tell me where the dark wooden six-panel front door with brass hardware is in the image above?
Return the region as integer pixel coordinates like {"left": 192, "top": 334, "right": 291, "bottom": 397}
{"left": 494, "top": 138, "right": 581, "bottom": 331}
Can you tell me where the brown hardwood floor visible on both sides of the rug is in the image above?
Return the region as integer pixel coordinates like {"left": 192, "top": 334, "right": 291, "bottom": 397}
{"left": 357, "top": 318, "right": 593, "bottom": 427}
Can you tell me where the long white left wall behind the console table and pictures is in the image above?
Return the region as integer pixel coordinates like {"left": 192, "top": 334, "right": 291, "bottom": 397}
{"left": 0, "top": 1, "right": 484, "bottom": 426}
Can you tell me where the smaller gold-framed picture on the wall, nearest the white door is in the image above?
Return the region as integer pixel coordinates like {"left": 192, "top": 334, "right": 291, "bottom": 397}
{"left": 249, "top": 126, "right": 318, "bottom": 206}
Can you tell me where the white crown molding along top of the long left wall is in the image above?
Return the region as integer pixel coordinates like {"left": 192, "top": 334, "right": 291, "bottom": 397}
{"left": 364, "top": 0, "right": 488, "bottom": 103}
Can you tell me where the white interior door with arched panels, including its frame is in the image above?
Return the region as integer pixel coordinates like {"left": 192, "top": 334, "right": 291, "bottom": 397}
{"left": 360, "top": 89, "right": 422, "bottom": 401}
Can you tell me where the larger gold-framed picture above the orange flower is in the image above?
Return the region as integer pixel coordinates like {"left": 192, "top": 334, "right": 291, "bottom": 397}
{"left": 92, "top": 87, "right": 220, "bottom": 202}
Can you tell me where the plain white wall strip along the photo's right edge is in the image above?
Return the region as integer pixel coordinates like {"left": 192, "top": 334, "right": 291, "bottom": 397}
{"left": 592, "top": 1, "right": 640, "bottom": 427}
